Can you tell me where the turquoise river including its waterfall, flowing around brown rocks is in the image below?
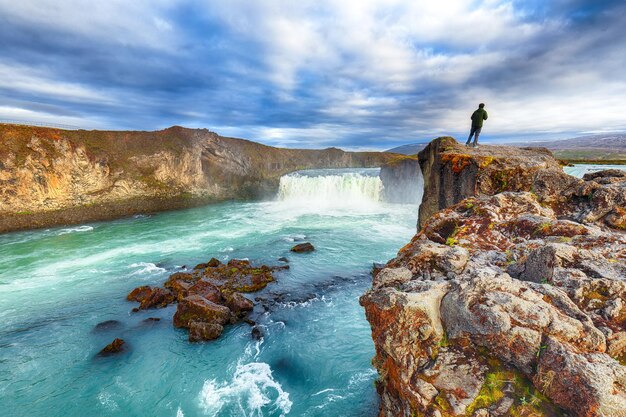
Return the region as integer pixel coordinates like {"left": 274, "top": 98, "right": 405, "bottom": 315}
{"left": 0, "top": 169, "right": 418, "bottom": 417}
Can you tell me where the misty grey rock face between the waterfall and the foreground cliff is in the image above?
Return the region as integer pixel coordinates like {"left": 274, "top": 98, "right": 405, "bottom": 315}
{"left": 380, "top": 155, "right": 423, "bottom": 204}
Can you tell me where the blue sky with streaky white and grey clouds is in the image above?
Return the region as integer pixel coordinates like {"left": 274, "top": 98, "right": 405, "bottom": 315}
{"left": 0, "top": 0, "right": 626, "bottom": 150}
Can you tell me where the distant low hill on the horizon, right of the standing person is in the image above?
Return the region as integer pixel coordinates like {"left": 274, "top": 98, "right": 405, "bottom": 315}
{"left": 518, "top": 133, "right": 626, "bottom": 162}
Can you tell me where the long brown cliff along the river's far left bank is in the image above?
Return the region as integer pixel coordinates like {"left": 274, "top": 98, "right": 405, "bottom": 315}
{"left": 0, "top": 124, "right": 393, "bottom": 232}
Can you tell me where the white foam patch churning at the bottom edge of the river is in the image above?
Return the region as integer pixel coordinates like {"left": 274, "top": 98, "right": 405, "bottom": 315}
{"left": 200, "top": 362, "right": 293, "bottom": 417}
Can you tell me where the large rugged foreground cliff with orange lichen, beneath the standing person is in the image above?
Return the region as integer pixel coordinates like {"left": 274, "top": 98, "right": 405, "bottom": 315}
{"left": 361, "top": 138, "right": 626, "bottom": 417}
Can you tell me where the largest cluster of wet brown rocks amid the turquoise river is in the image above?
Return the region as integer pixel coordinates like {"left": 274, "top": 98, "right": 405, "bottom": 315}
{"left": 126, "top": 258, "right": 282, "bottom": 342}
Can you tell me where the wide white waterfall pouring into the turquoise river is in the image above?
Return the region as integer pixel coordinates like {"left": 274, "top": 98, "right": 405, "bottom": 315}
{"left": 278, "top": 168, "right": 383, "bottom": 206}
